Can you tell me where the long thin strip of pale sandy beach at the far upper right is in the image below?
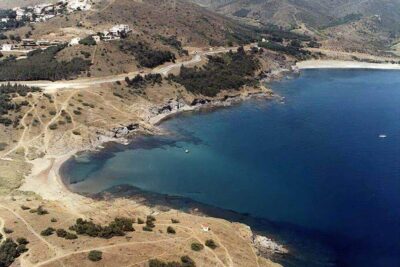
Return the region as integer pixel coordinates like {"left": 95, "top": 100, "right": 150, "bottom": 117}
{"left": 296, "top": 60, "right": 400, "bottom": 70}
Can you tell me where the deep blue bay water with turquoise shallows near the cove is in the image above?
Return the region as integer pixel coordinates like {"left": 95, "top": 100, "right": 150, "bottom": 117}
{"left": 61, "top": 70, "right": 400, "bottom": 267}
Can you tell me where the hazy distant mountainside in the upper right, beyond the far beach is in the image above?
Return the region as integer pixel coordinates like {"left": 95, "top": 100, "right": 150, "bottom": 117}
{"left": 190, "top": 0, "right": 400, "bottom": 50}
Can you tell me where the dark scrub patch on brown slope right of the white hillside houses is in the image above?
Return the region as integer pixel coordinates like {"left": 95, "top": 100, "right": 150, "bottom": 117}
{"left": 120, "top": 41, "right": 175, "bottom": 68}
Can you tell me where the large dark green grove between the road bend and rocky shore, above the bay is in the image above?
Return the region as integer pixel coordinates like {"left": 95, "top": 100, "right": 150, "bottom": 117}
{"left": 169, "top": 48, "right": 259, "bottom": 96}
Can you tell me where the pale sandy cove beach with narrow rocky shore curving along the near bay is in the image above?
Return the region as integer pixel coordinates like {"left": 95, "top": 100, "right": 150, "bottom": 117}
{"left": 19, "top": 88, "right": 274, "bottom": 214}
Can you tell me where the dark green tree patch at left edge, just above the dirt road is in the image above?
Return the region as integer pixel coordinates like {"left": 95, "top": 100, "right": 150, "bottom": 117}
{"left": 0, "top": 45, "right": 90, "bottom": 81}
